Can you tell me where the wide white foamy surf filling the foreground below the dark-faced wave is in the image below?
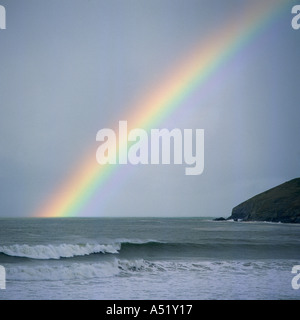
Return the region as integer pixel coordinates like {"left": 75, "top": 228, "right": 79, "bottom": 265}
{"left": 3, "top": 258, "right": 299, "bottom": 300}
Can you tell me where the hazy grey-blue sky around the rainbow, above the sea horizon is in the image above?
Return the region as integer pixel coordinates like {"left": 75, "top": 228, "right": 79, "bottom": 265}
{"left": 0, "top": 0, "right": 300, "bottom": 217}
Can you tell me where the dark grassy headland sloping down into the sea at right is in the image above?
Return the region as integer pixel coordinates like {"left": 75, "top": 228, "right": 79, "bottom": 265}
{"left": 228, "top": 178, "right": 300, "bottom": 223}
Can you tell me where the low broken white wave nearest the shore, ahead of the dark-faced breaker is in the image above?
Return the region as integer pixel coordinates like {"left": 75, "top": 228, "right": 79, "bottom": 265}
{"left": 6, "top": 258, "right": 296, "bottom": 282}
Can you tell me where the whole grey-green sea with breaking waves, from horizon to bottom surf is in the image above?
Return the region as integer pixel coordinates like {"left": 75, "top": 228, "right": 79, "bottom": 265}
{"left": 0, "top": 218, "right": 300, "bottom": 300}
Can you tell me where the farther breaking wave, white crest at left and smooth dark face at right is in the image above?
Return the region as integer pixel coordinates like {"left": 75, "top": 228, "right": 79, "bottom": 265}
{"left": 0, "top": 238, "right": 300, "bottom": 262}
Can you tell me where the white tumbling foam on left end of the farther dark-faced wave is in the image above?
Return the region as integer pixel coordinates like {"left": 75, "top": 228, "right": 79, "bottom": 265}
{"left": 0, "top": 243, "right": 120, "bottom": 259}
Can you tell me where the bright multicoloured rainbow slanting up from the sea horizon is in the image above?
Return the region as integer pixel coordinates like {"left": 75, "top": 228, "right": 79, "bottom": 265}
{"left": 33, "top": 0, "right": 290, "bottom": 217}
